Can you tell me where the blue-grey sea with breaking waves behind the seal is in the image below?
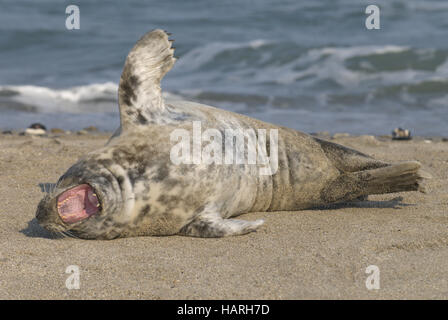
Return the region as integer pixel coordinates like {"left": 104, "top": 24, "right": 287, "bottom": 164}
{"left": 0, "top": 0, "right": 448, "bottom": 136}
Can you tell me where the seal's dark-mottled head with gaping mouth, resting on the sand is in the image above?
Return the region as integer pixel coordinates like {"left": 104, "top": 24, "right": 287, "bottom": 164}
{"left": 36, "top": 160, "right": 122, "bottom": 239}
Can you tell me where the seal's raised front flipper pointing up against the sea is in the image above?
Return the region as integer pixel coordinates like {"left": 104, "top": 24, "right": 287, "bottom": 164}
{"left": 118, "top": 29, "right": 176, "bottom": 130}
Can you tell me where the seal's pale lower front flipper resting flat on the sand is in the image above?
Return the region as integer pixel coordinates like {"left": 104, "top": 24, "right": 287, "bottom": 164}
{"left": 180, "top": 214, "right": 264, "bottom": 238}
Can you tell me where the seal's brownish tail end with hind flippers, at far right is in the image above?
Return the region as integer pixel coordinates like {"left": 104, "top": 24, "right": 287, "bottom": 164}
{"left": 322, "top": 161, "right": 431, "bottom": 203}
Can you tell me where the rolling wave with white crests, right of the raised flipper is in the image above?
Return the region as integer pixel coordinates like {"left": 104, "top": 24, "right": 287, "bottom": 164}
{"left": 175, "top": 40, "right": 448, "bottom": 93}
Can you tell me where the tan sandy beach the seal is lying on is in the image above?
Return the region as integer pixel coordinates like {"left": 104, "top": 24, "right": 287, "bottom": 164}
{"left": 0, "top": 133, "right": 448, "bottom": 299}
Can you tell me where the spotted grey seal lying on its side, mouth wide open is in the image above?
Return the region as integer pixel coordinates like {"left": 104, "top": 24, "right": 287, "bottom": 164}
{"left": 36, "top": 30, "right": 428, "bottom": 239}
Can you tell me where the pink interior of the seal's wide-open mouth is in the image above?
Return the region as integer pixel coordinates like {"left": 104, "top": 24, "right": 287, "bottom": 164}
{"left": 58, "top": 184, "right": 100, "bottom": 223}
